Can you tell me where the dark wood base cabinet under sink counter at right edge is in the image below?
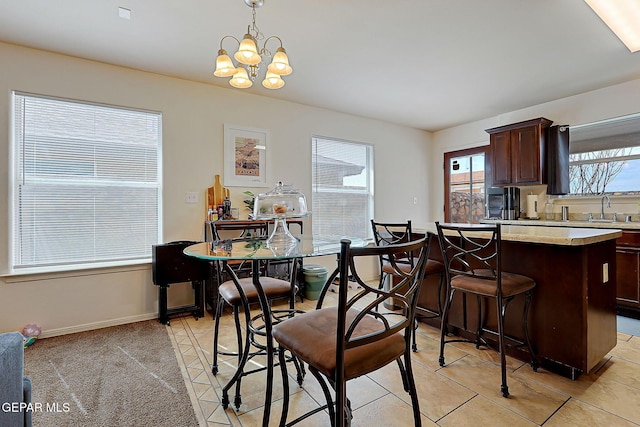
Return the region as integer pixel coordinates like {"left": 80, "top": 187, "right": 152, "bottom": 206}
{"left": 616, "top": 230, "right": 640, "bottom": 318}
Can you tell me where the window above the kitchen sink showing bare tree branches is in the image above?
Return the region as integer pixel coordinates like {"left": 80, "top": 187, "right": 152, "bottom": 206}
{"left": 569, "top": 114, "right": 640, "bottom": 195}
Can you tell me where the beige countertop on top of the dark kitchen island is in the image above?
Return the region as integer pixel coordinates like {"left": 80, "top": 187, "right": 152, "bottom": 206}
{"left": 414, "top": 222, "right": 622, "bottom": 246}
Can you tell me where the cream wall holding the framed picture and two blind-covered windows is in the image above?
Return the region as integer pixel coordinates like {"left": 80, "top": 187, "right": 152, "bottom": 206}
{"left": 0, "top": 43, "right": 432, "bottom": 336}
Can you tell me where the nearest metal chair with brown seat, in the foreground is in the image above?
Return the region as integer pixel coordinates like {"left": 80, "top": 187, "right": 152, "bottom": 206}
{"left": 273, "top": 238, "right": 429, "bottom": 426}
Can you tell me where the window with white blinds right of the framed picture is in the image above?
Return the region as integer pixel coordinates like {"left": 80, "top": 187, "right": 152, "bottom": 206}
{"left": 311, "top": 137, "right": 373, "bottom": 239}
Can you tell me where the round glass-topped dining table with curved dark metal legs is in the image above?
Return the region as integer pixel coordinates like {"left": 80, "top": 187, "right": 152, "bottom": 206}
{"left": 183, "top": 236, "right": 367, "bottom": 427}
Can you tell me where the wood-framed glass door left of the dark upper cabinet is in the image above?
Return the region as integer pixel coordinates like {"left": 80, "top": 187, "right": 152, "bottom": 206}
{"left": 444, "top": 146, "right": 487, "bottom": 223}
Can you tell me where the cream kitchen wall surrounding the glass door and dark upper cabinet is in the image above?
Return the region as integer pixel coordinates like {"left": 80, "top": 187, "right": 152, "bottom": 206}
{"left": 429, "top": 79, "right": 640, "bottom": 220}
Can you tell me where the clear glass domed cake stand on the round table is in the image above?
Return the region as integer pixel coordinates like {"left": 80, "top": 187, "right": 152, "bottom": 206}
{"left": 253, "top": 181, "right": 311, "bottom": 255}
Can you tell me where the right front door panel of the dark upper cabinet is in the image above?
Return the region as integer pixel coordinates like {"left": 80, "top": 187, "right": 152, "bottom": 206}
{"left": 511, "top": 126, "right": 541, "bottom": 184}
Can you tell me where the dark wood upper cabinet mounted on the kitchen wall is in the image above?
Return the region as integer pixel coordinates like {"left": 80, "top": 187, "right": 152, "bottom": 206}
{"left": 486, "top": 117, "right": 552, "bottom": 187}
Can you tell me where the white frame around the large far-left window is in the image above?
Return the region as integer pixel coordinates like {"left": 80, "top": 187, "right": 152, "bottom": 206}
{"left": 7, "top": 90, "right": 163, "bottom": 276}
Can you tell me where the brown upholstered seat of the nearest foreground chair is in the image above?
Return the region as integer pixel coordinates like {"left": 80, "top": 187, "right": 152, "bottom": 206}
{"left": 273, "top": 307, "right": 405, "bottom": 380}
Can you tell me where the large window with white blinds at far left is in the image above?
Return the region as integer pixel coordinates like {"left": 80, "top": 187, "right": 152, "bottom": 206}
{"left": 11, "top": 92, "right": 161, "bottom": 272}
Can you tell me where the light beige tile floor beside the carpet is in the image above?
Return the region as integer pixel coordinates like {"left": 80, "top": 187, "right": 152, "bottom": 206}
{"left": 167, "top": 294, "right": 640, "bottom": 427}
